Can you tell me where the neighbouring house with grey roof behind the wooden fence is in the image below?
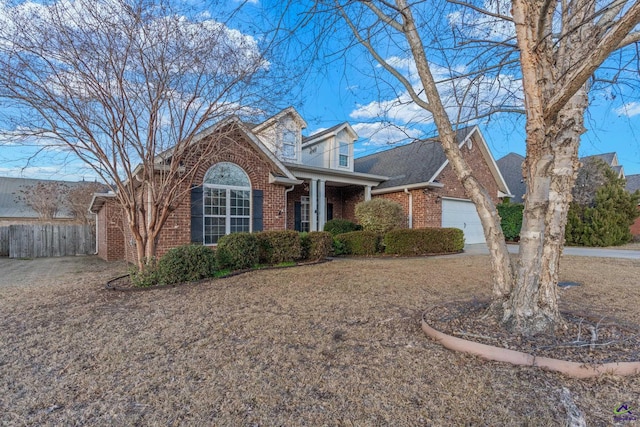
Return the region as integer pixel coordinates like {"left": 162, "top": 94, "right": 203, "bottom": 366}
{"left": 0, "top": 177, "right": 100, "bottom": 226}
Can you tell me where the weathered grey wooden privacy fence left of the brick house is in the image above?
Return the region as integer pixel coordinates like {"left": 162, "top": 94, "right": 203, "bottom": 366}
{"left": 0, "top": 224, "right": 96, "bottom": 258}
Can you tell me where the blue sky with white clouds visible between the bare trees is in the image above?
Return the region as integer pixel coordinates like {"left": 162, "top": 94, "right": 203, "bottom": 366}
{"left": 0, "top": 0, "right": 640, "bottom": 180}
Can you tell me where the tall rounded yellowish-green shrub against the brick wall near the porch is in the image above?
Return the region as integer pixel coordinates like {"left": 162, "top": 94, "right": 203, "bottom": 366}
{"left": 356, "top": 198, "right": 407, "bottom": 235}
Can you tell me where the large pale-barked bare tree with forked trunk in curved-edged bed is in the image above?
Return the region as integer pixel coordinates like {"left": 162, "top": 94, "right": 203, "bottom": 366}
{"left": 314, "top": 0, "right": 640, "bottom": 334}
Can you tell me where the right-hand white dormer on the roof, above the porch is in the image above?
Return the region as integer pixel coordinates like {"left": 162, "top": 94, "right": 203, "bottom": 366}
{"left": 302, "top": 122, "right": 358, "bottom": 172}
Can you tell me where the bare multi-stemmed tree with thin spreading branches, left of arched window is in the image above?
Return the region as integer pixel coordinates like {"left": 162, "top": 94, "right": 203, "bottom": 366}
{"left": 0, "top": 0, "right": 286, "bottom": 268}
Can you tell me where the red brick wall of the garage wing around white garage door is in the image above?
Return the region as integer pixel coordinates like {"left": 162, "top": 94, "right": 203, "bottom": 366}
{"left": 375, "top": 135, "right": 499, "bottom": 228}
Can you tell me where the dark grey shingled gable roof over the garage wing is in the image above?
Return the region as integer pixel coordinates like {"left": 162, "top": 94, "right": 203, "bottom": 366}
{"left": 354, "top": 126, "right": 510, "bottom": 194}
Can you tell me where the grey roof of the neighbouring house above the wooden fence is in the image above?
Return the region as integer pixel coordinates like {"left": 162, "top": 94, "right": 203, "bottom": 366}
{"left": 0, "top": 177, "right": 104, "bottom": 219}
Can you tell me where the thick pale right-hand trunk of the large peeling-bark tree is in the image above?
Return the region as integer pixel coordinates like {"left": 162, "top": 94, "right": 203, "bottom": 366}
{"left": 503, "top": 88, "right": 588, "bottom": 335}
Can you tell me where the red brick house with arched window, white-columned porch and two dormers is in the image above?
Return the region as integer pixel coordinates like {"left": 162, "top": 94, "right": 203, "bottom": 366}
{"left": 90, "top": 108, "right": 509, "bottom": 262}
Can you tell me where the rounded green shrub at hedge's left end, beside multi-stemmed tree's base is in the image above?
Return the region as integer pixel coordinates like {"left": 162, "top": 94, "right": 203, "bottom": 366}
{"left": 158, "top": 245, "right": 216, "bottom": 285}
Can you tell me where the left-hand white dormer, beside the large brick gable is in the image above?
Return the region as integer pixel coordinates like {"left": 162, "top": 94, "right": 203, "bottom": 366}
{"left": 251, "top": 107, "right": 307, "bottom": 163}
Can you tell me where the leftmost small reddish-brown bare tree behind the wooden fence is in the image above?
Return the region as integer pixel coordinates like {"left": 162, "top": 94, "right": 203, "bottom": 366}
{"left": 15, "top": 181, "right": 69, "bottom": 221}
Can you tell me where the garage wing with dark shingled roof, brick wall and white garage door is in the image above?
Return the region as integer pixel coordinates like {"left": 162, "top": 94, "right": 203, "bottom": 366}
{"left": 355, "top": 126, "right": 511, "bottom": 243}
